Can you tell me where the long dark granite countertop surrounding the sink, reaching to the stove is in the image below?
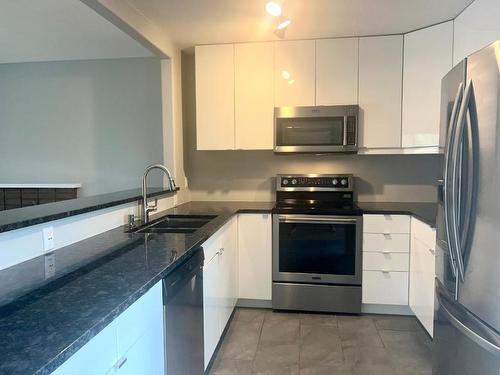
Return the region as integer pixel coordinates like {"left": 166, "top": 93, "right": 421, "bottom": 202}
{"left": 0, "top": 202, "right": 273, "bottom": 375}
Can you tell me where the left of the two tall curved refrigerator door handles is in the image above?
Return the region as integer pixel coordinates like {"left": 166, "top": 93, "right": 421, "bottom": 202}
{"left": 450, "top": 81, "right": 473, "bottom": 282}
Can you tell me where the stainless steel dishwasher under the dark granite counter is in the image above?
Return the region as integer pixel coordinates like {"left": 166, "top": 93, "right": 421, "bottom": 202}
{"left": 163, "top": 250, "right": 204, "bottom": 375}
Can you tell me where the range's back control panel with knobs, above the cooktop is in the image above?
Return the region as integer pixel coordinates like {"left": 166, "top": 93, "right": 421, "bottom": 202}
{"left": 276, "top": 174, "right": 353, "bottom": 191}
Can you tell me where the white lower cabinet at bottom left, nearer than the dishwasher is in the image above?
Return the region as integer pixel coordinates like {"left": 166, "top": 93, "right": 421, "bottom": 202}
{"left": 52, "top": 282, "right": 165, "bottom": 375}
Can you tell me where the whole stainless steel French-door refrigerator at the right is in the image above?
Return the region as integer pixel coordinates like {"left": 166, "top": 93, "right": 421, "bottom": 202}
{"left": 433, "top": 41, "right": 500, "bottom": 375}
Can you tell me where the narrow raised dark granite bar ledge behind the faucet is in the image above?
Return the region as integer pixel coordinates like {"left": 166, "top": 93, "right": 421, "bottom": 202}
{"left": 0, "top": 188, "right": 179, "bottom": 233}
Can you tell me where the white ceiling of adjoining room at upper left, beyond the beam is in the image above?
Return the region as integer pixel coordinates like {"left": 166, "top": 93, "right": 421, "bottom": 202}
{"left": 0, "top": 0, "right": 153, "bottom": 63}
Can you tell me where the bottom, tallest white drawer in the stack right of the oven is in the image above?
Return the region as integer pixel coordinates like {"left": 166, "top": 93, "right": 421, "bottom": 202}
{"left": 363, "top": 271, "right": 408, "bottom": 305}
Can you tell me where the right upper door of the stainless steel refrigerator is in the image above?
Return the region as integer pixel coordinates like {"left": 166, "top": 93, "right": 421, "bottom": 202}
{"left": 458, "top": 41, "right": 500, "bottom": 332}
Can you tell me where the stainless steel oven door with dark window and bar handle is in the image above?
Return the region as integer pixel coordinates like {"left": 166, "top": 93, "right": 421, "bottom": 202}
{"left": 273, "top": 215, "right": 362, "bottom": 285}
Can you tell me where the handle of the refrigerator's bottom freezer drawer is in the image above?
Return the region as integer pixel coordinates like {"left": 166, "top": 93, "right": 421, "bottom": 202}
{"left": 437, "top": 293, "right": 500, "bottom": 358}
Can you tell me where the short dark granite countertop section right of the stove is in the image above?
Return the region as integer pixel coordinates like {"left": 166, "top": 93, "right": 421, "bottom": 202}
{"left": 357, "top": 202, "right": 438, "bottom": 228}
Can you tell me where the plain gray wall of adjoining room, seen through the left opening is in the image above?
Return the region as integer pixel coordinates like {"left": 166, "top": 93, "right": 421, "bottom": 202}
{"left": 0, "top": 58, "right": 163, "bottom": 195}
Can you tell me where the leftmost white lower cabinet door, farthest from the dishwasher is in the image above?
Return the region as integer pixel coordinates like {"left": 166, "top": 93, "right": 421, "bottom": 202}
{"left": 52, "top": 322, "right": 117, "bottom": 375}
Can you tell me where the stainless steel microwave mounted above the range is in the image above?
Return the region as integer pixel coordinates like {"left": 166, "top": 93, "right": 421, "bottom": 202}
{"left": 274, "top": 105, "right": 359, "bottom": 153}
